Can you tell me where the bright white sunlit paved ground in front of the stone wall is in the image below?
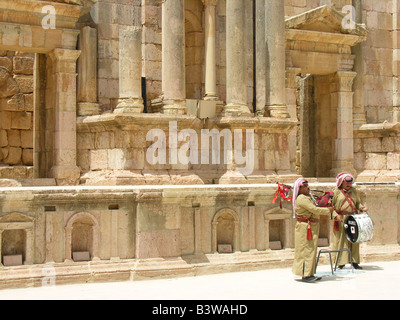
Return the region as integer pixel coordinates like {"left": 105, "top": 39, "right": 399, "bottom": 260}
{"left": 0, "top": 261, "right": 400, "bottom": 300}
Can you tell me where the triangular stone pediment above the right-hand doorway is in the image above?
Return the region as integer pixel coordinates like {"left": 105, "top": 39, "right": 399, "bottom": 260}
{"left": 286, "top": 6, "right": 368, "bottom": 46}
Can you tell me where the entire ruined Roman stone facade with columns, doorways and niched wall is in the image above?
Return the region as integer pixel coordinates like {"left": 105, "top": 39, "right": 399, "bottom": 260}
{"left": 0, "top": 0, "right": 400, "bottom": 287}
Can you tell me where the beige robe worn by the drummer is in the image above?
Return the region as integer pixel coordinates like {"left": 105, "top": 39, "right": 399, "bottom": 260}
{"left": 332, "top": 188, "right": 362, "bottom": 266}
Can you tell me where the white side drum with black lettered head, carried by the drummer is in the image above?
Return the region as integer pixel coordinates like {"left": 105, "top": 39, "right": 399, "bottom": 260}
{"left": 345, "top": 213, "right": 374, "bottom": 243}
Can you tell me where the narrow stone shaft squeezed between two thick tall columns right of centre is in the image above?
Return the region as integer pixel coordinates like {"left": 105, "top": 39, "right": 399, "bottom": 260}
{"left": 255, "top": 0, "right": 268, "bottom": 117}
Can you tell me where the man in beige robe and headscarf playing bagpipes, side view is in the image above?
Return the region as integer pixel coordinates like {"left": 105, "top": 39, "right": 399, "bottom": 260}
{"left": 292, "top": 179, "right": 333, "bottom": 282}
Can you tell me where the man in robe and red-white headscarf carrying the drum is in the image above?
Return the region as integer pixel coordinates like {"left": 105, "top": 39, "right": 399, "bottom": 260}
{"left": 332, "top": 172, "right": 368, "bottom": 269}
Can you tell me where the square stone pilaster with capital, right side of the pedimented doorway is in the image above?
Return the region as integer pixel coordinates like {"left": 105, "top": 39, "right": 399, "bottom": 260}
{"left": 331, "top": 71, "right": 357, "bottom": 177}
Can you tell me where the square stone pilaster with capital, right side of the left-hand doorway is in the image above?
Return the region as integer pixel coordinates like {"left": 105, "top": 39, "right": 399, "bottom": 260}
{"left": 49, "top": 49, "right": 80, "bottom": 185}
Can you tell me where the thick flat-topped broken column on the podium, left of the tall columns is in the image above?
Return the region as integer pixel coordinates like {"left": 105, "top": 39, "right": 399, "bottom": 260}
{"left": 114, "top": 26, "right": 144, "bottom": 113}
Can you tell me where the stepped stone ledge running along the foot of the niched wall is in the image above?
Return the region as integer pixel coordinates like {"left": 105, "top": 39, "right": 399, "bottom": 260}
{"left": 0, "top": 245, "right": 400, "bottom": 289}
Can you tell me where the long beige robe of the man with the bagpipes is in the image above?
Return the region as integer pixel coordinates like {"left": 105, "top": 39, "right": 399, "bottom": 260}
{"left": 292, "top": 194, "right": 331, "bottom": 277}
